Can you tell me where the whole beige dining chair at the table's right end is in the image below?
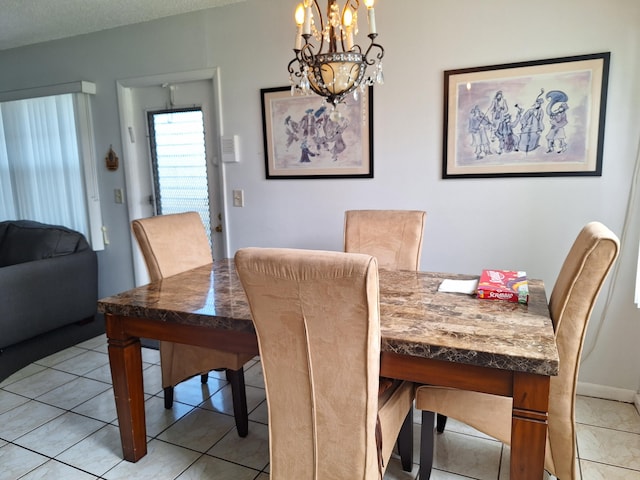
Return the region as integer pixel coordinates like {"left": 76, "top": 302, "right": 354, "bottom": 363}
{"left": 416, "top": 222, "right": 619, "bottom": 480}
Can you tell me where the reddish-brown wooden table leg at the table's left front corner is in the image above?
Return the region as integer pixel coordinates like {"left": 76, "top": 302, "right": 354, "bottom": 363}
{"left": 105, "top": 314, "right": 147, "bottom": 462}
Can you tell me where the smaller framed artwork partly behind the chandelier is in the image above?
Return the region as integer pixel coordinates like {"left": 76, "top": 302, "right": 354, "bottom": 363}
{"left": 260, "top": 87, "right": 373, "bottom": 179}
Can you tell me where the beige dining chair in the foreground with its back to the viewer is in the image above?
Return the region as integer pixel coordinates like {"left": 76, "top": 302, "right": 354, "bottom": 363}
{"left": 235, "top": 248, "right": 413, "bottom": 480}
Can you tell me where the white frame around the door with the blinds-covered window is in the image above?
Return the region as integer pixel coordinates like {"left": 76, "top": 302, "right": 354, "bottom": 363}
{"left": 116, "top": 67, "right": 229, "bottom": 285}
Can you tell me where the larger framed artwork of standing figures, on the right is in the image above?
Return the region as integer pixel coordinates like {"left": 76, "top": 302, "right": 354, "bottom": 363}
{"left": 442, "top": 52, "right": 610, "bottom": 179}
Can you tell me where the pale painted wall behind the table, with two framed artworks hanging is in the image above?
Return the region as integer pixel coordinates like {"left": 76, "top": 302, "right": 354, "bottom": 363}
{"left": 0, "top": 0, "right": 640, "bottom": 392}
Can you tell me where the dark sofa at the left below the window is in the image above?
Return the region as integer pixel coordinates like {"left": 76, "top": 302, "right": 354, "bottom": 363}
{"left": 0, "top": 220, "right": 104, "bottom": 381}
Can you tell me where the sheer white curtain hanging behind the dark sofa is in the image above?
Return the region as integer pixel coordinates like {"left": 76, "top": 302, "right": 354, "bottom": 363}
{"left": 0, "top": 94, "right": 89, "bottom": 236}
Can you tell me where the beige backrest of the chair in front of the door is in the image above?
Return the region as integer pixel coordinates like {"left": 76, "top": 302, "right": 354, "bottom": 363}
{"left": 131, "top": 212, "right": 213, "bottom": 281}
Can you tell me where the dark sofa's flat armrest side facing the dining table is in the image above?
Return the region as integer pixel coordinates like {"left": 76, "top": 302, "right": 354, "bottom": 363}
{"left": 0, "top": 250, "right": 98, "bottom": 349}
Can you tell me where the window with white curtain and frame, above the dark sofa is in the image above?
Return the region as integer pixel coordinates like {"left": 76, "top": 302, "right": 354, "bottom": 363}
{"left": 0, "top": 82, "right": 104, "bottom": 250}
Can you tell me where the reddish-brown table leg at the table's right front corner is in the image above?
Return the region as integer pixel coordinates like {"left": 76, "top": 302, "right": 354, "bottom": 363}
{"left": 510, "top": 373, "right": 549, "bottom": 480}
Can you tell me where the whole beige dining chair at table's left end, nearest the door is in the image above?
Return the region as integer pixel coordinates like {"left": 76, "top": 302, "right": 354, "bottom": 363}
{"left": 131, "top": 212, "right": 253, "bottom": 437}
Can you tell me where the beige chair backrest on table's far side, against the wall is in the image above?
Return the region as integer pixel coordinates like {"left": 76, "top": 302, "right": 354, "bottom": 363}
{"left": 344, "top": 210, "right": 427, "bottom": 270}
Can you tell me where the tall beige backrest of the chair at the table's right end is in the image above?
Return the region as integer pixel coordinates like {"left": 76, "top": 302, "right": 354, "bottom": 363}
{"left": 548, "top": 222, "right": 620, "bottom": 478}
